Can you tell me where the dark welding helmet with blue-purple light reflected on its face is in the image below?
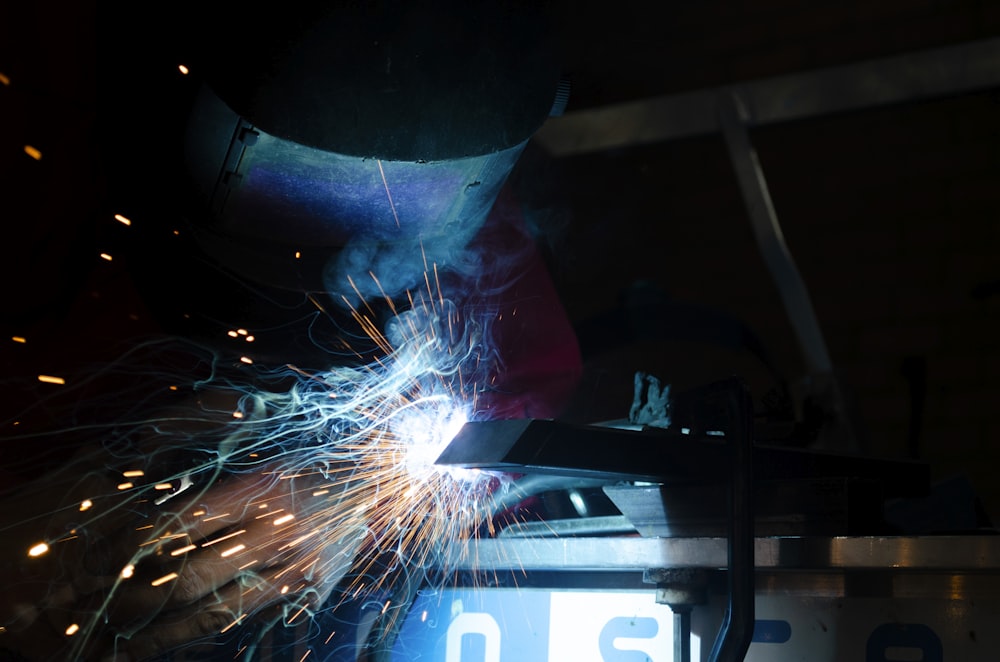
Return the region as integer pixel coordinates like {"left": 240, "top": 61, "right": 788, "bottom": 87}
{"left": 110, "top": 0, "right": 565, "bottom": 364}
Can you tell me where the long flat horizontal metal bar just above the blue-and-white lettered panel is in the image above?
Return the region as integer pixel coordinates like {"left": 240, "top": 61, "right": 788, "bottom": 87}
{"left": 449, "top": 535, "right": 1000, "bottom": 574}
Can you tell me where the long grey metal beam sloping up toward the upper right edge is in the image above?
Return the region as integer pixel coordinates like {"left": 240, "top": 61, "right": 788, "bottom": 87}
{"left": 534, "top": 38, "right": 1000, "bottom": 157}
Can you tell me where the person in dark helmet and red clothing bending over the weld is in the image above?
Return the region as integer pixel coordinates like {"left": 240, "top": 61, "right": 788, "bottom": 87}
{"left": 5, "top": 0, "right": 580, "bottom": 659}
